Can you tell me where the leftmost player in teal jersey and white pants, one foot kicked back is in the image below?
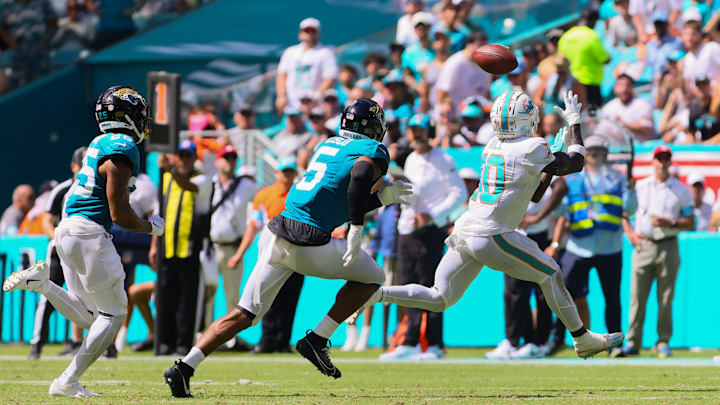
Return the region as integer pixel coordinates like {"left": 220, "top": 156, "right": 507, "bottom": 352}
{"left": 3, "top": 86, "right": 165, "bottom": 397}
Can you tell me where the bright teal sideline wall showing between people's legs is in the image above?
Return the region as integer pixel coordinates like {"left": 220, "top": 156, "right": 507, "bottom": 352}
{"left": 0, "top": 227, "right": 720, "bottom": 348}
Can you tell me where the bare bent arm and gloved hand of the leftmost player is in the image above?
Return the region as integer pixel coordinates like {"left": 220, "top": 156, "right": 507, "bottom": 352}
{"left": 99, "top": 156, "right": 165, "bottom": 235}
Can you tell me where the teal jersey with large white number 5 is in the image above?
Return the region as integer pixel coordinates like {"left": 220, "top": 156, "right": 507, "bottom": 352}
{"left": 280, "top": 136, "right": 390, "bottom": 233}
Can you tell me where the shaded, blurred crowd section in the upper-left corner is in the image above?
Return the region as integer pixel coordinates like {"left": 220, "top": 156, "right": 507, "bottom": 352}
{"left": 0, "top": 0, "right": 207, "bottom": 94}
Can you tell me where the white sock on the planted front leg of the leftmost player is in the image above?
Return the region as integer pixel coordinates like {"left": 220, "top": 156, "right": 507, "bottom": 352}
{"left": 57, "top": 312, "right": 125, "bottom": 384}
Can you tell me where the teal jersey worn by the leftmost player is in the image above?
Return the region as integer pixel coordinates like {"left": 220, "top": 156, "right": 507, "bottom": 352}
{"left": 65, "top": 133, "right": 140, "bottom": 233}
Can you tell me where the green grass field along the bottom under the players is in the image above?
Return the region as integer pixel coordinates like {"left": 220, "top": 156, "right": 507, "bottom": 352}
{"left": 0, "top": 345, "right": 720, "bottom": 405}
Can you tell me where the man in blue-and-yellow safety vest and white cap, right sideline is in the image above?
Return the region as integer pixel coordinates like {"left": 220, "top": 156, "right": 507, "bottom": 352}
{"left": 542, "top": 135, "right": 637, "bottom": 355}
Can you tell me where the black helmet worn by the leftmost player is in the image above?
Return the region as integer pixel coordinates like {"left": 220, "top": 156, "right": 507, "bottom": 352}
{"left": 95, "top": 86, "right": 151, "bottom": 144}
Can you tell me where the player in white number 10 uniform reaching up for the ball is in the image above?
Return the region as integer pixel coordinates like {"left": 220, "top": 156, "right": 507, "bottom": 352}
{"left": 348, "top": 91, "right": 624, "bottom": 358}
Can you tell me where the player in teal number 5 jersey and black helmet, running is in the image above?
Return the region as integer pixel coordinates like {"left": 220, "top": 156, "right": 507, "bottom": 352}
{"left": 165, "top": 98, "right": 410, "bottom": 397}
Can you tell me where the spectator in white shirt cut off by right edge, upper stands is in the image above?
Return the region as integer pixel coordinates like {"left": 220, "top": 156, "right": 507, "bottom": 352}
{"left": 680, "top": 21, "right": 720, "bottom": 89}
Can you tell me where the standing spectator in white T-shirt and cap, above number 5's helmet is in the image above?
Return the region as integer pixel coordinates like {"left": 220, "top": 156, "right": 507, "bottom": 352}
{"left": 275, "top": 18, "right": 338, "bottom": 111}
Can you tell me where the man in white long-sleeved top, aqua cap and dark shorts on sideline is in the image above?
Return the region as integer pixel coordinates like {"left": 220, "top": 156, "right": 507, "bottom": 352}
{"left": 380, "top": 114, "right": 467, "bottom": 360}
